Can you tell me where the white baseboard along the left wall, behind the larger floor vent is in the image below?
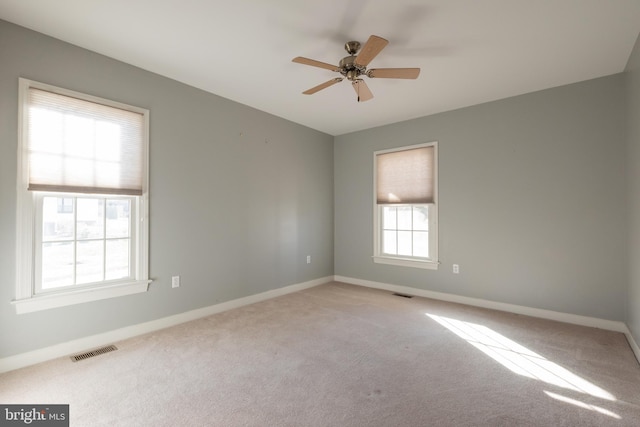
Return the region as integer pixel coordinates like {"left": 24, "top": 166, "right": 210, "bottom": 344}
{"left": 0, "top": 276, "right": 333, "bottom": 373}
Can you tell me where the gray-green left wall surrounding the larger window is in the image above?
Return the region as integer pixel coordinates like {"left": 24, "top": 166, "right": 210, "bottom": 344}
{"left": 0, "top": 21, "right": 333, "bottom": 357}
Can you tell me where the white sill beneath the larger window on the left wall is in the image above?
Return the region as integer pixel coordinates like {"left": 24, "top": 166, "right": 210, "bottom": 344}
{"left": 11, "top": 280, "right": 151, "bottom": 314}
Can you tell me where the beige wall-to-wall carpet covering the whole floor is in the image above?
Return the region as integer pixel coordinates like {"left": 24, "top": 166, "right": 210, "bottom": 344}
{"left": 0, "top": 283, "right": 640, "bottom": 426}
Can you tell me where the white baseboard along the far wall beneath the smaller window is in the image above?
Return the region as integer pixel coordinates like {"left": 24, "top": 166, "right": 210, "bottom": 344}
{"left": 334, "top": 276, "right": 631, "bottom": 336}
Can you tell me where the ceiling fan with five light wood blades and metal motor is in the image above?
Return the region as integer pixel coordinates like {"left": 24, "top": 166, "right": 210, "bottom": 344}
{"left": 292, "top": 35, "right": 420, "bottom": 102}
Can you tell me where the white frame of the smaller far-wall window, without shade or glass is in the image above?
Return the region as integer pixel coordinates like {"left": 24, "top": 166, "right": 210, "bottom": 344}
{"left": 373, "top": 141, "right": 440, "bottom": 270}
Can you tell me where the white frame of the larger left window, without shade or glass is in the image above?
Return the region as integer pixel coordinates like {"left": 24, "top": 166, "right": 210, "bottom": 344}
{"left": 12, "top": 78, "right": 151, "bottom": 314}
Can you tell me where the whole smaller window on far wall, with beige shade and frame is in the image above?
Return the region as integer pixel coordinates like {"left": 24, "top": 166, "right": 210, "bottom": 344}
{"left": 373, "top": 142, "right": 438, "bottom": 269}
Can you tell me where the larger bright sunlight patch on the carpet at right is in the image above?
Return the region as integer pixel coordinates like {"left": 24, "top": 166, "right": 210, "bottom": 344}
{"left": 426, "top": 313, "right": 616, "bottom": 401}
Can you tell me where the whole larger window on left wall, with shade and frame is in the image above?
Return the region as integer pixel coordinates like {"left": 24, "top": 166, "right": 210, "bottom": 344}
{"left": 13, "top": 79, "right": 149, "bottom": 313}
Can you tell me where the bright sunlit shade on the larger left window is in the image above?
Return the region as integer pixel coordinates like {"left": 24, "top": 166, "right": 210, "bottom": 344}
{"left": 27, "top": 88, "right": 145, "bottom": 195}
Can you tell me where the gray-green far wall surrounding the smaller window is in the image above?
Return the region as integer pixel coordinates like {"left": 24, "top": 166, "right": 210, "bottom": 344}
{"left": 334, "top": 74, "right": 637, "bottom": 320}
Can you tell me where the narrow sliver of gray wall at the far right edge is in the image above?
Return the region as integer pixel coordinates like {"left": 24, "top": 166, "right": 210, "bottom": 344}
{"left": 626, "top": 37, "right": 640, "bottom": 343}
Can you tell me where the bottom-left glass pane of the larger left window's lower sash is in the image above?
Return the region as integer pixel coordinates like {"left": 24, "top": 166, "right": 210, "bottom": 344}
{"left": 42, "top": 242, "right": 73, "bottom": 289}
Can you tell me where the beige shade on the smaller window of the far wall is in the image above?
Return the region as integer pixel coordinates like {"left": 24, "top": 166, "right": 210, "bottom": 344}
{"left": 376, "top": 146, "right": 435, "bottom": 205}
